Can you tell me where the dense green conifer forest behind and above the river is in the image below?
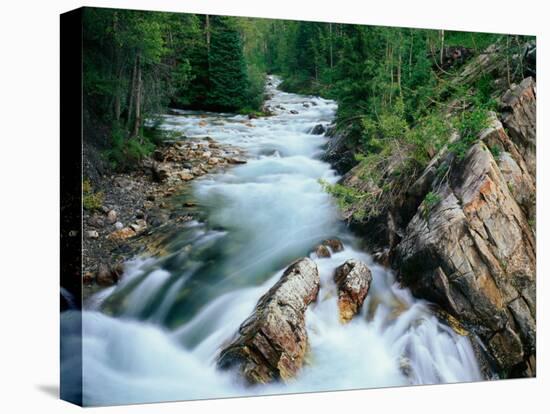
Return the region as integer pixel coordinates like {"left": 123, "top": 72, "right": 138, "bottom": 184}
{"left": 84, "top": 8, "right": 529, "bottom": 173}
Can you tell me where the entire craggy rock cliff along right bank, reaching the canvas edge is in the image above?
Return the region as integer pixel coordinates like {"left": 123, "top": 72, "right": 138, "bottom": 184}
{"left": 329, "top": 55, "right": 536, "bottom": 377}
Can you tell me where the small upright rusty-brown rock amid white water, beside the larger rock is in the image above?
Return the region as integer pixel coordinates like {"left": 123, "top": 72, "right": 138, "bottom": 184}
{"left": 334, "top": 259, "right": 372, "bottom": 323}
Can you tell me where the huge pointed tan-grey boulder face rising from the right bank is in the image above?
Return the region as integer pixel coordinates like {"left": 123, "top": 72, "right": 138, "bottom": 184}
{"left": 394, "top": 141, "right": 536, "bottom": 372}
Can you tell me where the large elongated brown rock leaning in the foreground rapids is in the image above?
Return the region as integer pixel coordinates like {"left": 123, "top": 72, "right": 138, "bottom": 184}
{"left": 218, "top": 258, "right": 320, "bottom": 384}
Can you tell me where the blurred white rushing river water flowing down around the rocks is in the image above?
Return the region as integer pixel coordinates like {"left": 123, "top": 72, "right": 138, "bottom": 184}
{"left": 63, "top": 78, "right": 481, "bottom": 405}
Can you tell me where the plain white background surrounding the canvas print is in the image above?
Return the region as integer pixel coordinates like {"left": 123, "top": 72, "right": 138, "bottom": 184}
{"left": 0, "top": 0, "right": 550, "bottom": 414}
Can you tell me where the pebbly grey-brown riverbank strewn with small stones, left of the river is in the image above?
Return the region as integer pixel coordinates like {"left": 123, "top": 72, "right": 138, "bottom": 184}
{"left": 82, "top": 136, "right": 246, "bottom": 300}
